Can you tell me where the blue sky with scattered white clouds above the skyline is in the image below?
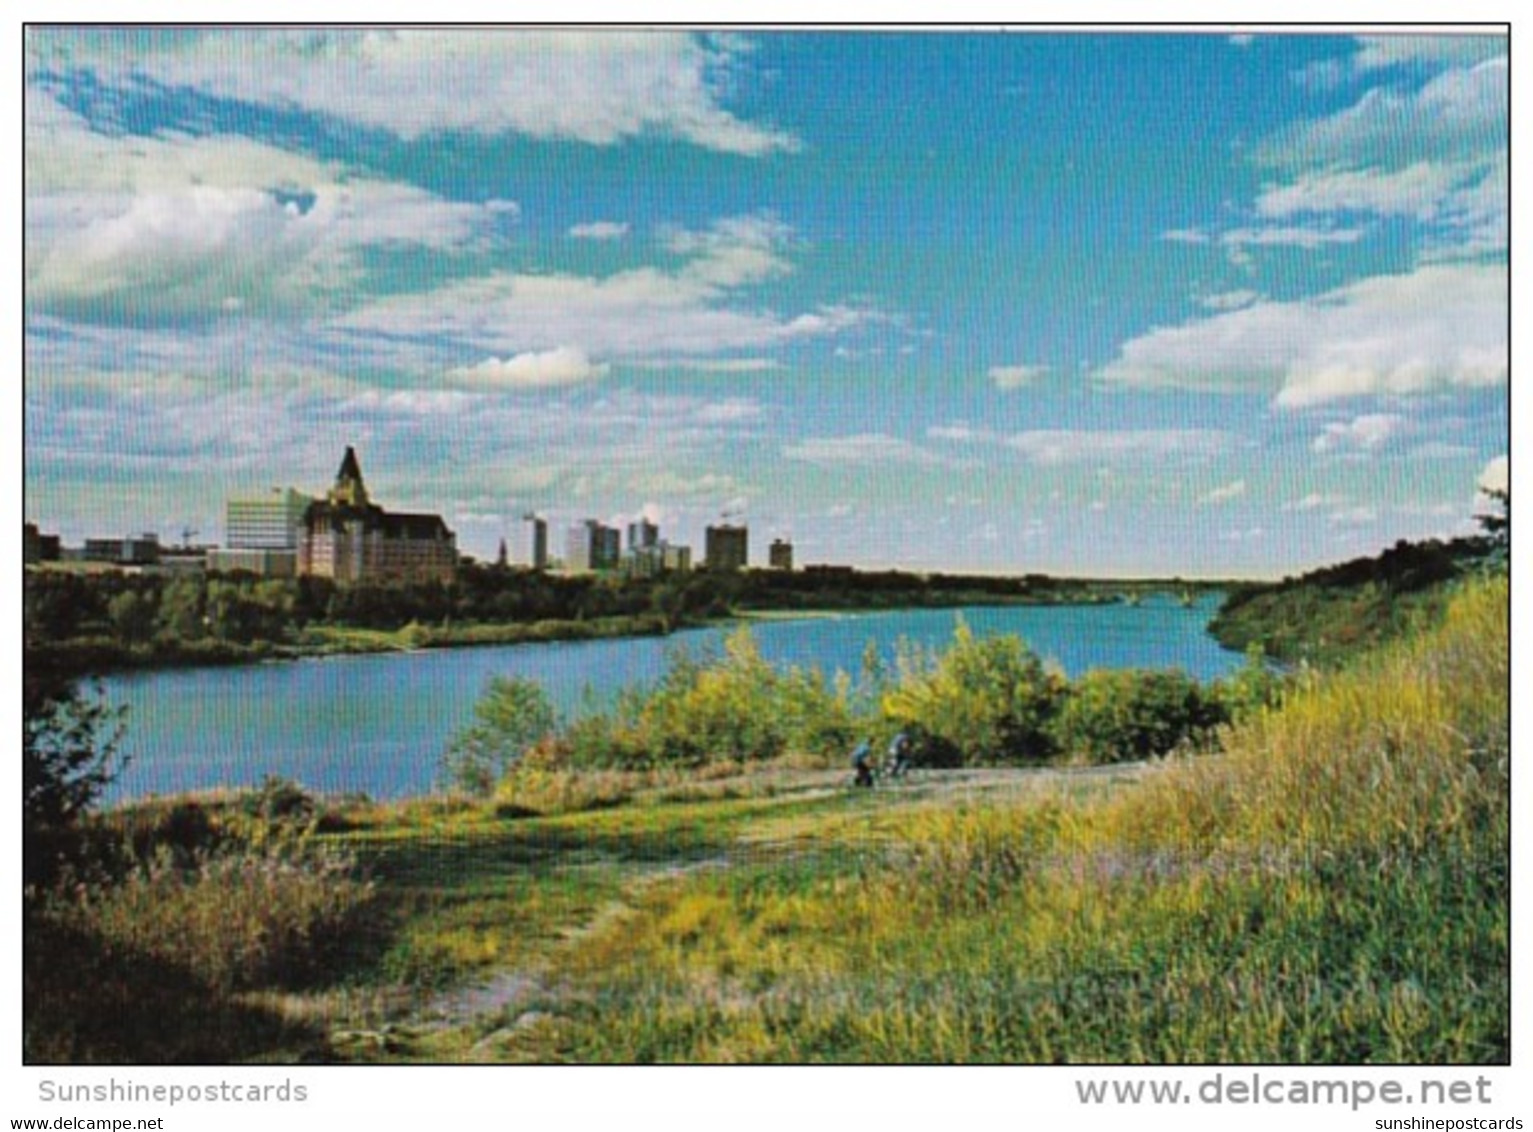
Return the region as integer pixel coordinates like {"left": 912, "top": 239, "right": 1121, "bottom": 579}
{"left": 25, "top": 29, "right": 1508, "bottom": 575}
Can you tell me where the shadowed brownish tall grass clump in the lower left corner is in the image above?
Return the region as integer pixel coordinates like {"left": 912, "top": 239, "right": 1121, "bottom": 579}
{"left": 25, "top": 782, "right": 376, "bottom": 1061}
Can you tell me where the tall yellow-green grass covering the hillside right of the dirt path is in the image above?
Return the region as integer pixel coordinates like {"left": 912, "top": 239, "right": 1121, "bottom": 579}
{"left": 539, "top": 580, "right": 1510, "bottom": 1063}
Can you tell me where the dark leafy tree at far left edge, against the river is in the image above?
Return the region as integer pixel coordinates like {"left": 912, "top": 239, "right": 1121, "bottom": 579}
{"left": 21, "top": 673, "right": 126, "bottom": 830}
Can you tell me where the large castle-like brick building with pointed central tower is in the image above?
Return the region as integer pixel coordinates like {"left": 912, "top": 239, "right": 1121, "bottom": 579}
{"left": 297, "top": 448, "right": 458, "bottom": 581}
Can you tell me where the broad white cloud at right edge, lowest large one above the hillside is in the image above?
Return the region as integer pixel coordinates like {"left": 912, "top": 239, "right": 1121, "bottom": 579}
{"left": 1096, "top": 264, "right": 1507, "bottom": 408}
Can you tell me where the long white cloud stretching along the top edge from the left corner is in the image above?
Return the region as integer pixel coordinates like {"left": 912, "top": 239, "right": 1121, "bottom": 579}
{"left": 28, "top": 28, "right": 799, "bottom": 156}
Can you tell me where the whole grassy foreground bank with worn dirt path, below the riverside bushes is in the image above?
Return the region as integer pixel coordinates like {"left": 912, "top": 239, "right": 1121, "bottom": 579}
{"left": 28, "top": 581, "right": 1510, "bottom": 1065}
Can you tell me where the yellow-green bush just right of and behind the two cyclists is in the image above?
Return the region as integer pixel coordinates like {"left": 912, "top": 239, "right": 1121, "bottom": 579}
{"left": 883, "top": 618, "right": 1065, "bottom": 765}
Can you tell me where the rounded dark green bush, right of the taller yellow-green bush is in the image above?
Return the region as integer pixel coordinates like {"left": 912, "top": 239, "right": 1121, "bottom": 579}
{"left": 1053, "top": 669, "right": 1228, "bottom": 762}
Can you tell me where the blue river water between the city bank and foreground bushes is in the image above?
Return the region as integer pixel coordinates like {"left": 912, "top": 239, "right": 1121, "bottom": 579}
{"left": 106, "top": 595, "right": 1243, "bottom": 801}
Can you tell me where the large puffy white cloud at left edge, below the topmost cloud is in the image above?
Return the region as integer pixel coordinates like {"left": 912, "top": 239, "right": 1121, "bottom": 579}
{"left": 25, "top": 116, "right": 502, "bottom": 325}
